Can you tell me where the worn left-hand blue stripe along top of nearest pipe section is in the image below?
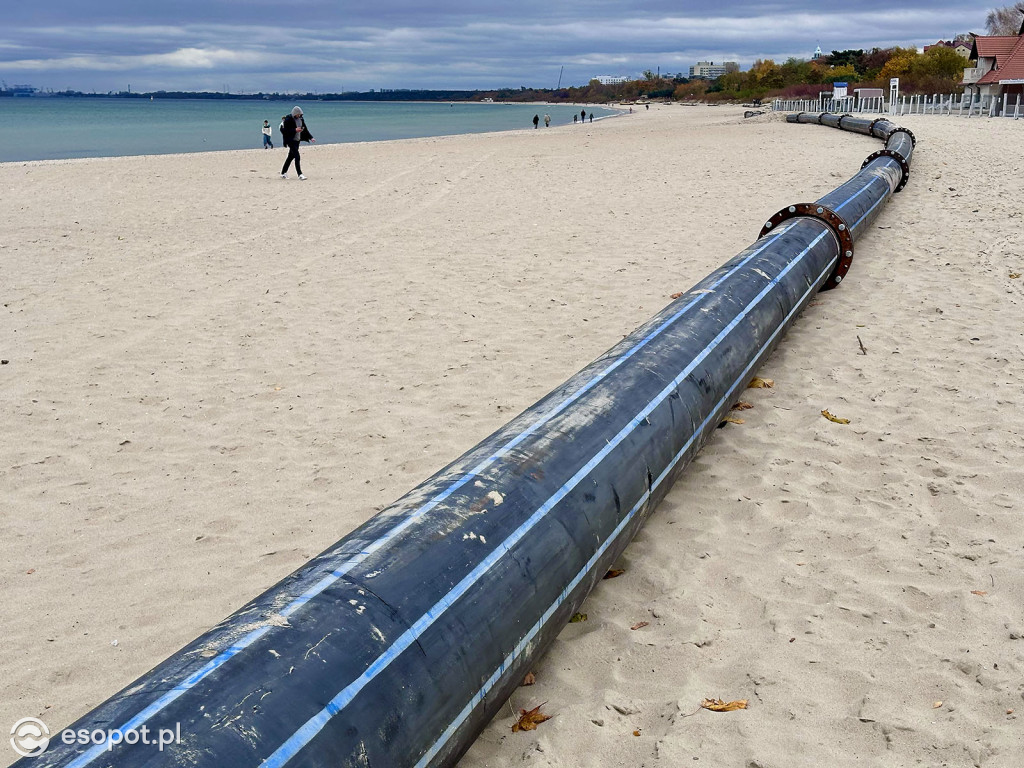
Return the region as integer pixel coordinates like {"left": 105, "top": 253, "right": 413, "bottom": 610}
{"left": 54, "top": 231, "right": 782, "bottom": 768}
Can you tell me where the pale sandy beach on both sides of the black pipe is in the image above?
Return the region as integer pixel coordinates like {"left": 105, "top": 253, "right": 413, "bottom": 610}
{"left": 0, "top": 104, "right": 1024, "bottom": 768}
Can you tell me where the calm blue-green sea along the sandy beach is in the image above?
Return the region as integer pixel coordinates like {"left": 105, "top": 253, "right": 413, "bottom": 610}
{"left": 0, "top": 97, "right": 615, "bottom": 162}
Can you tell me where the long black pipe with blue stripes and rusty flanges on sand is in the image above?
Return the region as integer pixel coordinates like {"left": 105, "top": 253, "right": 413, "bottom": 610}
{"left": 16, "top": 116, "right": 912, "bottom": 768}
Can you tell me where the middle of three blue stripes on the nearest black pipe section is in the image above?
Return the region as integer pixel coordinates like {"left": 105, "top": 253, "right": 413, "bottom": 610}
{"left": 260, "top": 229, "right": 831, "bottom": 768}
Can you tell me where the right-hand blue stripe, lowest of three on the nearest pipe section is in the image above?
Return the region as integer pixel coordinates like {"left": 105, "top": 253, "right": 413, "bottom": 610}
{"left": 416, "top": 247, "right": 836, "bottom": 768}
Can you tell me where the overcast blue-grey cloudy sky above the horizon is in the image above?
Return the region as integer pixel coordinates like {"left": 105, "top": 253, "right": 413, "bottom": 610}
{"left": 0, "top": 0, "right": 1010, "bottom": 93}
